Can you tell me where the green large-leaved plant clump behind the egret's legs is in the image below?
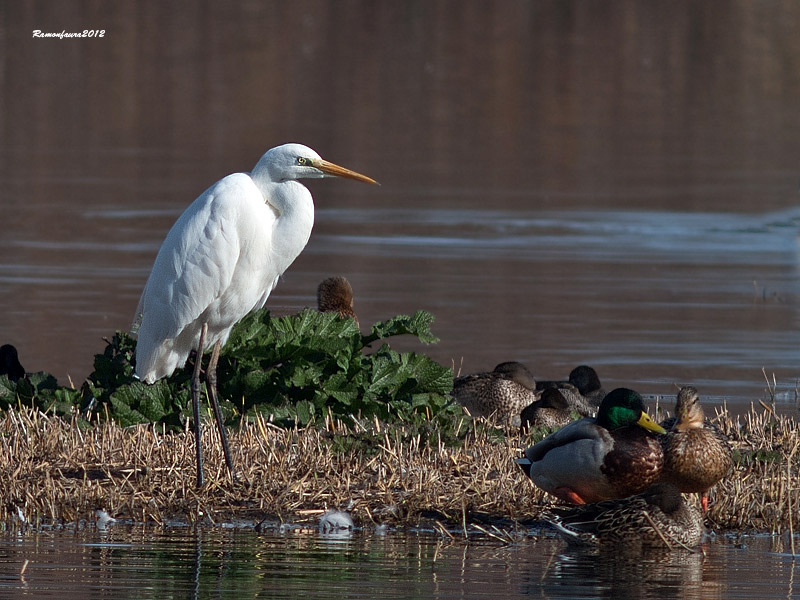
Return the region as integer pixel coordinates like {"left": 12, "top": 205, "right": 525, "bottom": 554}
{"left": 80, "top": 310, "right": 456, "bottom": 427}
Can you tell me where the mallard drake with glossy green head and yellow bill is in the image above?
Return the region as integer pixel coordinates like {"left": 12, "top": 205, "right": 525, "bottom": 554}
{"left": 517, "top": 388, "right": 664, "bottom": 504}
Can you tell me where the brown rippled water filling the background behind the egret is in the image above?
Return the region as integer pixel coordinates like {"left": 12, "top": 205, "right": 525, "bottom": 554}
{"left": 0, "top": 0, "right": 800, "bottom": 411}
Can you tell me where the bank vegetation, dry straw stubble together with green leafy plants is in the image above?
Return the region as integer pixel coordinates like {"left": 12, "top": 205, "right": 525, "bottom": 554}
{"left": 0, "top": 304, "right": 800, "bottom": 532}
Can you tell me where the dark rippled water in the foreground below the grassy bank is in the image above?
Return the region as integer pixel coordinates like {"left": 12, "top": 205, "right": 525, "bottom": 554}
{"left": 0, "top": 525, "right": 800, "bottom": 600}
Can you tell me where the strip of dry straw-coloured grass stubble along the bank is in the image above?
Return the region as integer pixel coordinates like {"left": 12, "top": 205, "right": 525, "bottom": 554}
{"left": 0, "top": 400, "right": 800, "bottom": 532}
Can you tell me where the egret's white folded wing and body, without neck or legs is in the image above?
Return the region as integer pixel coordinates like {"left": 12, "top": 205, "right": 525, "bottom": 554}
{"left": 136, "top": 173, "right": 278, "bottom": 383}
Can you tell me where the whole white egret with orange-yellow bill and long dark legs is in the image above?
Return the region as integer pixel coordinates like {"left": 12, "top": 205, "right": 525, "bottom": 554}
{"left": 133, "top": 144, "right": 377, "bottom": 487}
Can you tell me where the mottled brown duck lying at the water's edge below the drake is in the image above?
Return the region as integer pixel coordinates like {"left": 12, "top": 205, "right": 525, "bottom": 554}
{"left": 546, "top": 482, "right": 705, "bottom": 548}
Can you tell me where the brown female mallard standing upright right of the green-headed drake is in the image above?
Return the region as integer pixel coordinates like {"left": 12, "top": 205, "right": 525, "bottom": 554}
{"left": 661, "top": 386, "right": 733, "bottom": 511}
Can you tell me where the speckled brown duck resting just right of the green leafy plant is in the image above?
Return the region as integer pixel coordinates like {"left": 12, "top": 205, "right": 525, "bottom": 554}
{"left": 453, "top": 362, "right": 540, "bottom": 426}
